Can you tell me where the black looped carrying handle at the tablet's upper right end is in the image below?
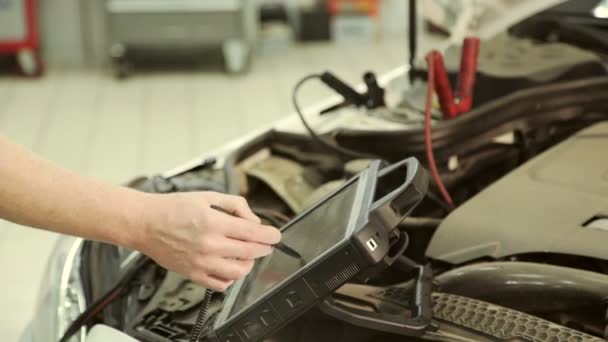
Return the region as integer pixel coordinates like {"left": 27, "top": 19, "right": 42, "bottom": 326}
{"left": 371, "top": 157, "right": 429, "bottom": 226}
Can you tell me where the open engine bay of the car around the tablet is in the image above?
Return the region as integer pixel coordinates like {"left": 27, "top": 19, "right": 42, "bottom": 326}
{"left": 71, "top": 18, "right": 608, "bottom": 342}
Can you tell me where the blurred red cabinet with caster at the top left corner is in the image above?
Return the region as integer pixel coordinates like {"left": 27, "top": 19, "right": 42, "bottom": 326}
{"left": 0, "top": 0, "right": 43, "bottom": 76}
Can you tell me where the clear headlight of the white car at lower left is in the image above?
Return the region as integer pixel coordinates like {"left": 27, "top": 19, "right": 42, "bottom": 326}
{"left": 30, "top": 237, "right": 86, "bottom": 342}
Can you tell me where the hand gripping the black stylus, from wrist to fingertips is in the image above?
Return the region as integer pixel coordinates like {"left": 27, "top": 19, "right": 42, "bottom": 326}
{"left": 135, "top": 192, "right": 281, "bottom": 292}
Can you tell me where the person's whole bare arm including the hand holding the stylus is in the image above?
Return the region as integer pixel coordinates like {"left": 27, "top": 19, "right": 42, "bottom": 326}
{"left": 0, "top": 137, "right": 281, "bottom": 291}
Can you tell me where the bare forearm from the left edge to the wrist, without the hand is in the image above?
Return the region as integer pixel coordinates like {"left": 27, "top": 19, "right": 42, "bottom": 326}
{"left": 0, "top": 137, "right": 153, "bottom": 247}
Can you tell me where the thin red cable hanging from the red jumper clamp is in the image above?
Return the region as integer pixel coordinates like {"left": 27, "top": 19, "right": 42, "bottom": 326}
{"left": 424, "top": 50, "right": 454, "bottom": 209}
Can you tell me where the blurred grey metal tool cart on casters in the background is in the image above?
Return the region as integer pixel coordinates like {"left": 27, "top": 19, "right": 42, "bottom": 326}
{"left": 106, "top": 0, "right": 258, "bottom": 77}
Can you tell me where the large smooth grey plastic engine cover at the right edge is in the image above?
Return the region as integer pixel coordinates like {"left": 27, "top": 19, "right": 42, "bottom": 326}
{"left": 427, "top": 122, "right": 608, "bottom": 264}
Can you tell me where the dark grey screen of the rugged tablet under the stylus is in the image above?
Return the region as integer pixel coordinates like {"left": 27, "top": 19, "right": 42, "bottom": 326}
{"left": 229, "top": 181, "right": 358, "bottom": 317}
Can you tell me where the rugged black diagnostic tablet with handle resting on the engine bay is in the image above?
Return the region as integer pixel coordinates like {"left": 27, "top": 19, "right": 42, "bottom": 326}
{"left": 206, "top": 158, "right": 428, "bottom": 342}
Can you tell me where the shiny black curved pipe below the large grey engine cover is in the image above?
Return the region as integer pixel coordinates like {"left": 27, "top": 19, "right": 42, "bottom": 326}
{"left": 435, "top": 261, "right": 608, "bottom": 335}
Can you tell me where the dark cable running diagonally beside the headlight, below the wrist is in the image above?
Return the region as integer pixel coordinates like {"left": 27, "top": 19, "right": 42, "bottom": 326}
{"left": 59, "top": 254, "right": 151, "bottom": 342}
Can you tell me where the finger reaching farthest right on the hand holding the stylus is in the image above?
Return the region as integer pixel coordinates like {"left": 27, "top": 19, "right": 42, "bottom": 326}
{"left": 220, "top": 217, "right": 281, "bottom": 245}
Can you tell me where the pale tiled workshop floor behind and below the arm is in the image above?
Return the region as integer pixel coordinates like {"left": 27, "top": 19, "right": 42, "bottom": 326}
{"left": 0, "top": 37, "right": 430, "bottom": 341}
